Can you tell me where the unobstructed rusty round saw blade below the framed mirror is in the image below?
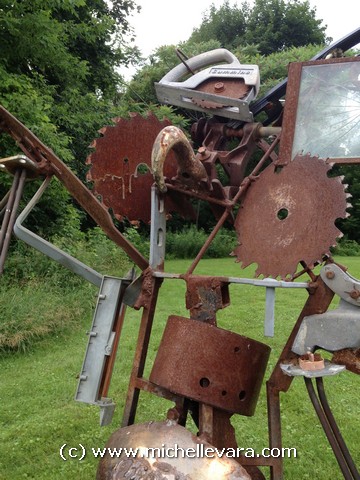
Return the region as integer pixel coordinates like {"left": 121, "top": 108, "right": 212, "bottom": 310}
{"left": 234, "top": 155, "right": 350, "bottom": 279}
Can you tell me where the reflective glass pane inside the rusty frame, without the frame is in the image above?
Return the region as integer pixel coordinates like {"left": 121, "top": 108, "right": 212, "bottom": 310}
{"left": 292, "top": 62, "right": 360, "bottom": 159}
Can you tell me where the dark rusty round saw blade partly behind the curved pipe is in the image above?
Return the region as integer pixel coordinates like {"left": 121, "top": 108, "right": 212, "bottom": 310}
{"left": 86, "top": 114, "right": 181, "bottom": 224}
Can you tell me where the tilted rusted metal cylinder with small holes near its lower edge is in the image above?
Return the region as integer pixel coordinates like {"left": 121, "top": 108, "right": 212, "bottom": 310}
{"left": 150, "top": 316, "right": 271, "bottom": 416}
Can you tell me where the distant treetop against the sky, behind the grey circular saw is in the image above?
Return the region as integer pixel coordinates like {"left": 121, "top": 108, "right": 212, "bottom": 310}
{"left": 190, "top": 0, "right": 329, "bottom": 55}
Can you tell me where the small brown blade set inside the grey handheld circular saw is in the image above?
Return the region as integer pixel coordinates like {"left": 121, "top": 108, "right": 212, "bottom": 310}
{"left": 191, "top": 78, "right": 251, "bottom": 108}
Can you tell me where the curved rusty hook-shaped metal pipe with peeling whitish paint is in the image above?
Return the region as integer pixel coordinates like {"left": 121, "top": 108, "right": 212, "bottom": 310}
{"left": 151, "top": 125, "right": 207, "bottom": 193}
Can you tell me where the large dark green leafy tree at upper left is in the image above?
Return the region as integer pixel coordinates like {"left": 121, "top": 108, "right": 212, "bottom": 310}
{"left": 0, "top": 0, "right": 138, "bottom": 234}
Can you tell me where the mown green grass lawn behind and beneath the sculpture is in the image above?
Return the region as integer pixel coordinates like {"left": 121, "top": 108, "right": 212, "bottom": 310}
{"left": 0, "top": 257, "right": 360, "bottom": 480}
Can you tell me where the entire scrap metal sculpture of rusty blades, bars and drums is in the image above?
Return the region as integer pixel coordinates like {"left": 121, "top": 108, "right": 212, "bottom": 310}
{"left": 0, "top": 29, "right": 360, "bottom": 480}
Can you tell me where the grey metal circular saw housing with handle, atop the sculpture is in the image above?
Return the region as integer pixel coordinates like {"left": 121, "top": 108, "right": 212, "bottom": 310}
{"left": 155, "top": 48, "right": 260, "bottom": 122}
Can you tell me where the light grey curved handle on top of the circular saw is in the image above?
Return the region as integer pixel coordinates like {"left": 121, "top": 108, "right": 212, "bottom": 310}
{"left": 160, "top": 48, "right": 240, "bottom": 83}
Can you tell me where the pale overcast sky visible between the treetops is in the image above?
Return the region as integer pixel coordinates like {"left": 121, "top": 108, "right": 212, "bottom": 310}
{"left": 122, "top": 0, "right": 360, "bottom": 78}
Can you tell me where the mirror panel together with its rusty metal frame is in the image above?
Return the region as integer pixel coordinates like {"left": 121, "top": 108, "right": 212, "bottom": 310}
{"left": 279, "top": 57, "right": 360, "bottom": 164}
